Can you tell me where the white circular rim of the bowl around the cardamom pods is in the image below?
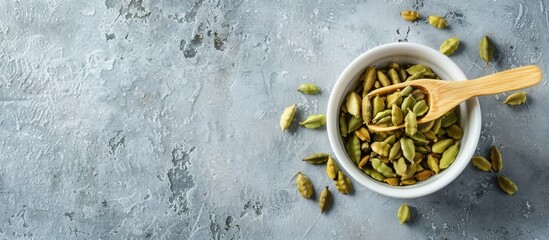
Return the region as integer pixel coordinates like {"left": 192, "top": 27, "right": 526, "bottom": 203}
{"left": 326, "top": 42, "right": 482, "bottom": 198}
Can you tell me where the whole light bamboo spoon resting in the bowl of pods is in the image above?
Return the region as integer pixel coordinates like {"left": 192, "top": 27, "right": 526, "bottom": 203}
{"left": 368, "top": 65, "right": 541, "bottom": 131}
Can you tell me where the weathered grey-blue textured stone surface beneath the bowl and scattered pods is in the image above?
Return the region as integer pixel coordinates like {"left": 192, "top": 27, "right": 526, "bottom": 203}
{"left": 0, "top": 0, "right": 549, "bottom": 239}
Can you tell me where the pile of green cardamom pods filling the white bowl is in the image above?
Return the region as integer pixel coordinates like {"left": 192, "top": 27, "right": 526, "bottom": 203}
{"left": 339, "top": 63, "right": 463, "bottom": 186}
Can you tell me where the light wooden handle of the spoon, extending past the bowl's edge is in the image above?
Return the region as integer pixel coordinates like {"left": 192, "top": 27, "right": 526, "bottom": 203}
{"left": 452, "top": 65, "right": 542, "bottom": 98}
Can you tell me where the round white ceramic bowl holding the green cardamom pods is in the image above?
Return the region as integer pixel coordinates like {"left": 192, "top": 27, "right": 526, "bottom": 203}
{"left": 326, "top": 43, "right": 482, "bottom": 198}
